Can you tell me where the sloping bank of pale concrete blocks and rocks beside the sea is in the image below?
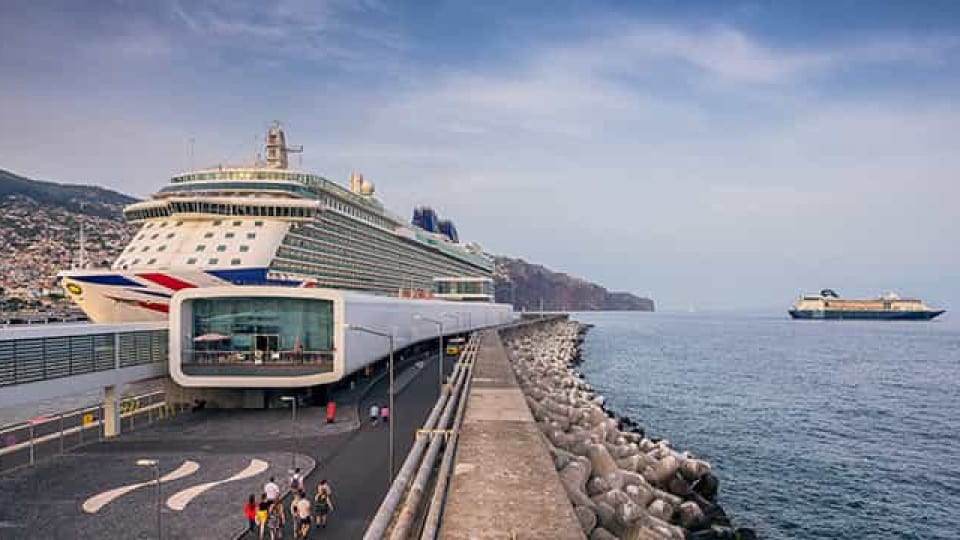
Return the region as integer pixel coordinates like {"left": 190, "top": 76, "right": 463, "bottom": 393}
{"left": 502, "top": 319, "right": 755, "bottom": 540}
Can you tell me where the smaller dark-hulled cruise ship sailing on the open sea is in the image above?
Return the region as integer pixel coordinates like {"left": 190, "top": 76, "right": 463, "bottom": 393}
{"left": 788, "top": 289, "right": 945, "bottom": 321}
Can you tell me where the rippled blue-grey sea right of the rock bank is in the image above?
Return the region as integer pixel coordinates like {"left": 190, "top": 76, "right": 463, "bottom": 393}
{"left": 574, "top": 313, "right": 960, "bottom": 540}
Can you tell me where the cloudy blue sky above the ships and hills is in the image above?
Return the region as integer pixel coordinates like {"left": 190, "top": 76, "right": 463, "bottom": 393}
{"left": 0, "top": 0, "right": 960, "bottom": 309}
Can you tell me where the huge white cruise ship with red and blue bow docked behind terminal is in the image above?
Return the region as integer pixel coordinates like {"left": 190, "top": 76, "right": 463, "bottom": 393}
{"left": 59, "top": 124, "right": 493, "bottom": 322}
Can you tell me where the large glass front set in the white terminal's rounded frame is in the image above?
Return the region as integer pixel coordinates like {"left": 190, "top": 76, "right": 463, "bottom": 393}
{"left": 183, "top": 297, "right": 333, "bottom": 367}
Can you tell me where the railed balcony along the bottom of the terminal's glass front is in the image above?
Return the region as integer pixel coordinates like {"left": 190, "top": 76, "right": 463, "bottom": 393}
{"left": 181, "top": 349, "right": 334, "bottom": 377}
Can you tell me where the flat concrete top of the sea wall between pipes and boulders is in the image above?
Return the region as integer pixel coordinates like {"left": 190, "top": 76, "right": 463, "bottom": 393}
{"left": 440, "top": 330, "right": 584, "bottom": 540}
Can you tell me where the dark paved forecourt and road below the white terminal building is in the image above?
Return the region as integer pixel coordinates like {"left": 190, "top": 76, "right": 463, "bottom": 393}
{"left": 0, "top": 348, "right": 453, "bottom": 540}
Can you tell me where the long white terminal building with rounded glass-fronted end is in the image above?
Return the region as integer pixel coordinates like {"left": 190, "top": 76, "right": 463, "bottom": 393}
{"left": 169, "top": 286, "right": 514, "bottom": 388}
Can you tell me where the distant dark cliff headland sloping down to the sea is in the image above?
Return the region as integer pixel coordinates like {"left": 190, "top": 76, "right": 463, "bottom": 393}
{"left": 495, "top": 257, "right": 654, "bottom": 311}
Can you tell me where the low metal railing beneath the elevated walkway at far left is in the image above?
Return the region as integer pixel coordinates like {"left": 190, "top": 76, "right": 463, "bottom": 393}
{"left": 0, "top": 390, "right": 186, "bottom": 471}
